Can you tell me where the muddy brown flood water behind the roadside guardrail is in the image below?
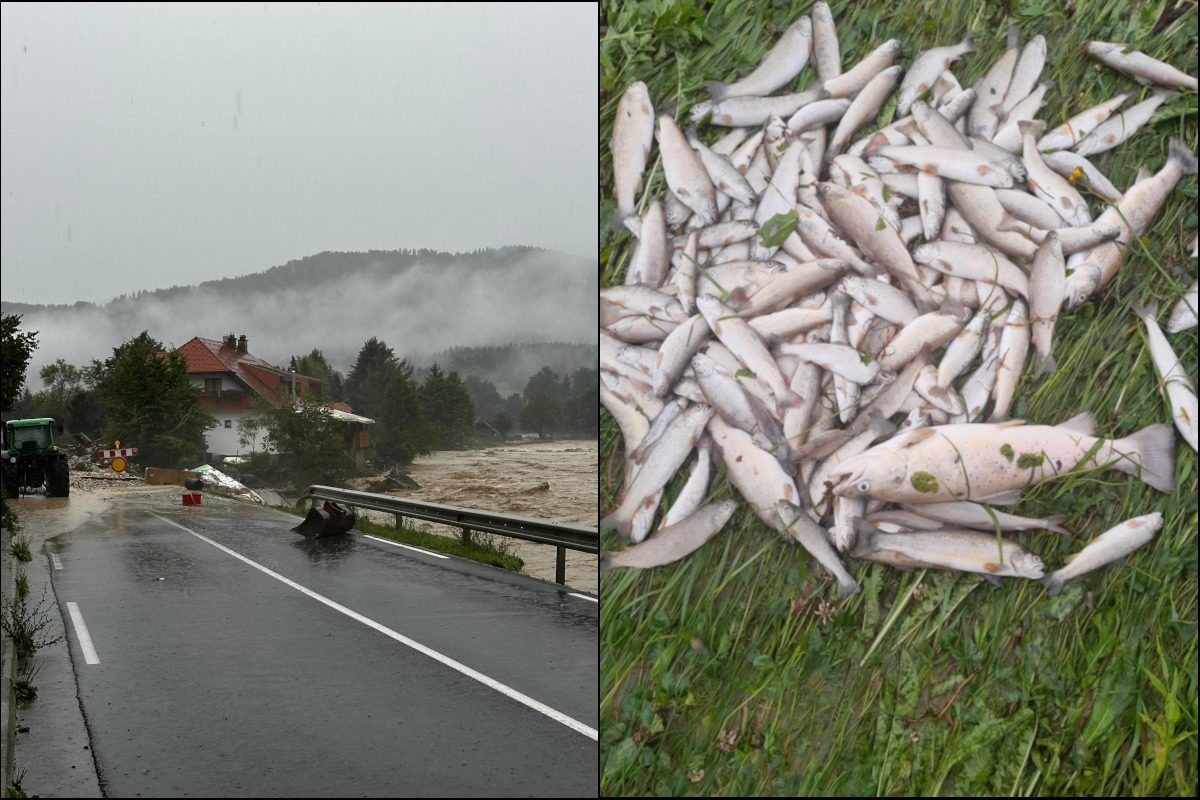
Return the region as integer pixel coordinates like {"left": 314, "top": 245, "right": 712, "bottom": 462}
{"left": 360, "top": 440, "right": 599, "bottom": 594}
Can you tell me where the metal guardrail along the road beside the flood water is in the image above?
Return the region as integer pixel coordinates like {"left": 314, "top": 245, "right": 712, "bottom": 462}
{"left": 300, "top": 485, "right": 600, "bottom": 584}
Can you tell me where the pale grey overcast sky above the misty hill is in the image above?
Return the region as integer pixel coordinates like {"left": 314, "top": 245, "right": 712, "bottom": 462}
{"left": 0, "top": 2, "right": 599, "bottom": 303}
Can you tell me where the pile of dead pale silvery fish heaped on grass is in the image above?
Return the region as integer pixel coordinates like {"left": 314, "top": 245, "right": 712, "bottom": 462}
{"left": 600, "top": 2, "right": 1196, "bottom": 594}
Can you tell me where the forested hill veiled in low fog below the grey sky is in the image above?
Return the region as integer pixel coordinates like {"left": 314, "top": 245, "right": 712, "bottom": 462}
{"left": 0, "top": 247, "right": 599, "bottom": 390}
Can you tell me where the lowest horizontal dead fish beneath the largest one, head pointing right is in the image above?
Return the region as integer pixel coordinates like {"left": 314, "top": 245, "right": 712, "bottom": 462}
{"left": 851, "top": 527, "right": 1045, "bottom": 584}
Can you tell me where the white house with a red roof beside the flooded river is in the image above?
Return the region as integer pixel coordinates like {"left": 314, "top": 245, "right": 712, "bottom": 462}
{"left": 178, "top": 333, "right": 374, "bottom": 459}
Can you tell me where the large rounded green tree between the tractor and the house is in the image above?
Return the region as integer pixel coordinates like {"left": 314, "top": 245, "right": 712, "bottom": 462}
{"left": 96, "top": 331, "right": 216, "bottom": 467}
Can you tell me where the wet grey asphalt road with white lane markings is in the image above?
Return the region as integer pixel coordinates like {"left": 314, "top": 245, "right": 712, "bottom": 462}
{"left": 48, "top": 494, "right": 599, "bottom": 796}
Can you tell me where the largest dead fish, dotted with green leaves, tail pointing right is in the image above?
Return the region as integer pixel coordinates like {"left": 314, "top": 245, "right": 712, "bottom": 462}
{"left": 830, "top": 414, "right": 1175, "bottom": 505}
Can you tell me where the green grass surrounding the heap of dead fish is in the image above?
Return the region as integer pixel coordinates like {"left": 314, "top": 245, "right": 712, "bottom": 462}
{"left": 599, "top": 0, "right": 1198, "bottom": 795}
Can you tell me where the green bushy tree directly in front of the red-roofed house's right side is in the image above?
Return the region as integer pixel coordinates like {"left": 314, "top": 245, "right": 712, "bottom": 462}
{"left": 265, "top": 403, "right": 354, "bottom": 487}
